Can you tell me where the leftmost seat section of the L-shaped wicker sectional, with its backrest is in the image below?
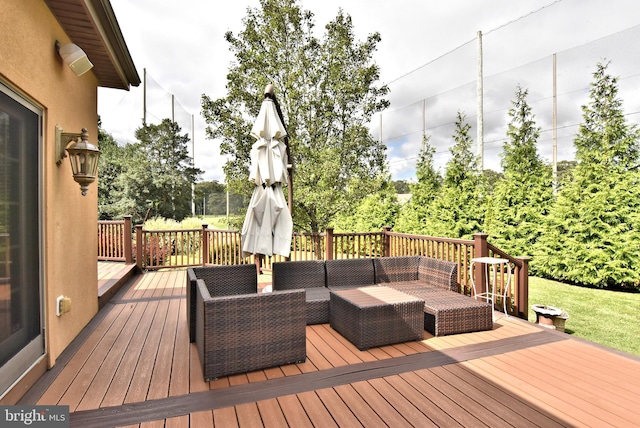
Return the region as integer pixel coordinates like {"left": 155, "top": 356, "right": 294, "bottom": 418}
{"left": 271, "top": 260, "right": 329, "bottom": 325}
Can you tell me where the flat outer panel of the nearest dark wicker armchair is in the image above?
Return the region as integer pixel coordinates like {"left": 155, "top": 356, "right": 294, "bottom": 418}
{"left": 196, "top": 280, "right": 306, "bottom": 381}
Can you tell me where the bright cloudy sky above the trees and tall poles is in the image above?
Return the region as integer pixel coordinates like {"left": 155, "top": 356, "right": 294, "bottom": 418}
{"left": 98, "top": 0, "right": 640, "bottom": 182}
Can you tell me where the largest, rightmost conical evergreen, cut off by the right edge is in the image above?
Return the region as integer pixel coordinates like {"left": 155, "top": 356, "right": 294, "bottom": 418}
{"left": 536, "top": 64, "right": 640, "bottom": 287}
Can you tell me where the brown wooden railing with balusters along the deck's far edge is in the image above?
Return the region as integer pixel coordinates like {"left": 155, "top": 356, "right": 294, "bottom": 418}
{"left": 107, "top": 222, "right": 529, "bottom": 319}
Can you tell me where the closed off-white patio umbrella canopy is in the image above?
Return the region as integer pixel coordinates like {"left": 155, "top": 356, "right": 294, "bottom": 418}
{"left": 242, "top": 86, "right": 293, "bottom": 257}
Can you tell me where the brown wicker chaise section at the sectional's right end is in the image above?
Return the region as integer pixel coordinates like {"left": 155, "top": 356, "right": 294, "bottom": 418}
{"left": 412, "top": 290, "right": 493, "bottom": 336}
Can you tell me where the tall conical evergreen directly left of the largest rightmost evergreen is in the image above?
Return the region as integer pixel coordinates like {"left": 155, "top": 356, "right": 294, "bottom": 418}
{"left": 485, "top": 86, "right": 553, "bottom": 262}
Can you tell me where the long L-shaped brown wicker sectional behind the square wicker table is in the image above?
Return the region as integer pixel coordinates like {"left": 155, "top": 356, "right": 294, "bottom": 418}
{"left": 272, "top": 256, "right": 493, "bottom": 336}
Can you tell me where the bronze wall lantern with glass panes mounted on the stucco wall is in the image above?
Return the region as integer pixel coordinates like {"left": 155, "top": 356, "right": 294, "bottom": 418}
{"left": 56, "top": 127, "right": 102, "bottom": 196}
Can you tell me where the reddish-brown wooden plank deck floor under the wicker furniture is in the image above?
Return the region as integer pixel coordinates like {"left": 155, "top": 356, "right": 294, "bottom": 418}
{"left": 19, "top": 270, "right": 640, "bottom": 427}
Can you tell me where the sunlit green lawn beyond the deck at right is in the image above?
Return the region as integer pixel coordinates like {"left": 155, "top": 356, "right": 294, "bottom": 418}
{"left": 529, "top": 277, "right": 640, "bottom": 356}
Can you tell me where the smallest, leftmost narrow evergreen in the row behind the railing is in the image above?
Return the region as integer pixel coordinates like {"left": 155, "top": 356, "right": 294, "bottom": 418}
{"left": 394, "top": 136, "right": 442, "bottom": 234}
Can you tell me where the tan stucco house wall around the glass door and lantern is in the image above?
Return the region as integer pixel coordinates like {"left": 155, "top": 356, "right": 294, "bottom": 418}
{"left": 0, "top": 0, "right": 98, "bottom": 366}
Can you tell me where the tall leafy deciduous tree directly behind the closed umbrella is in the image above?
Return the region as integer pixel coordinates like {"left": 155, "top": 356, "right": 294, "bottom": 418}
{"left": 202, "top": 0, "right": 388, "bottom": 231}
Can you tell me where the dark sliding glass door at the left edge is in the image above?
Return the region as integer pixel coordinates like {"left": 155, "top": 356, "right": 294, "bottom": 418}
{"left": 0, "top": 82, "right": 44, "bottom": 396}
